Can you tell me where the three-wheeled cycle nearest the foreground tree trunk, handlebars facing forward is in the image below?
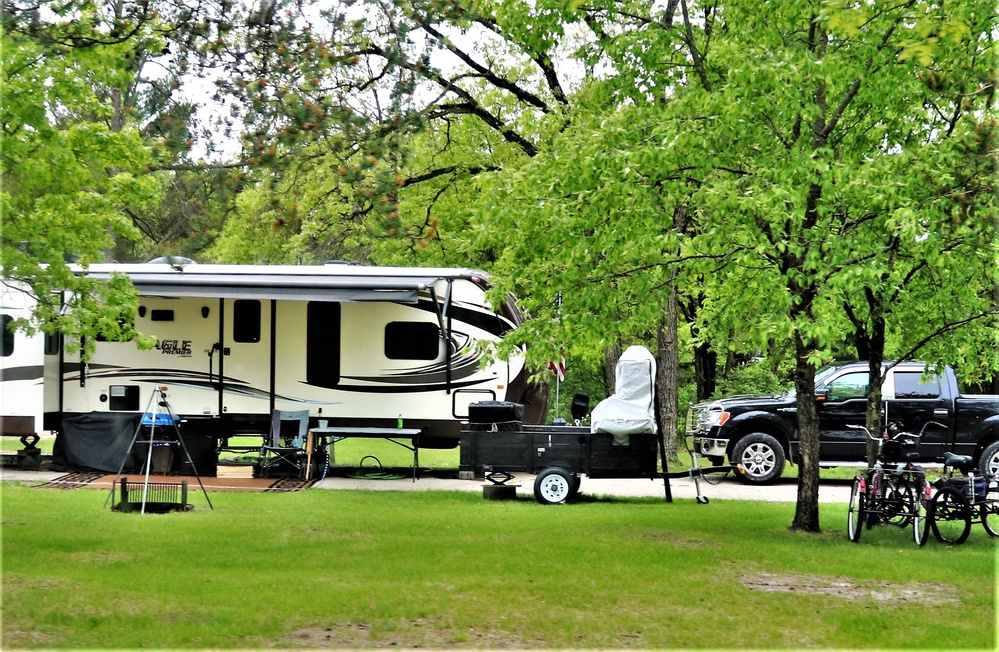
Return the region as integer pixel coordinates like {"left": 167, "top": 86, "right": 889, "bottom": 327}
{"left": 846, "top": 422, "right": 933, "bottom": 546}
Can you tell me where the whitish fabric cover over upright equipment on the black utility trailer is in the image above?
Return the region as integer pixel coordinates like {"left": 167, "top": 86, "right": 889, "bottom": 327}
{"left": 590, "top": 345, "right": 657, "bottom": 446}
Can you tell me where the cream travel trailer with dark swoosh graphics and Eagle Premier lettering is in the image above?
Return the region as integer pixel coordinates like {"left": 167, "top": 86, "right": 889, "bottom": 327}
{"left": 46, "top": 264, "right": 544, "bottom": 448}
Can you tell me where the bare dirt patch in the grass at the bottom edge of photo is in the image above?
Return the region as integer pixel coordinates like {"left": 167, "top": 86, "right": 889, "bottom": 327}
{"left": 276, "top": 618, "right": 532, "bottom": 650}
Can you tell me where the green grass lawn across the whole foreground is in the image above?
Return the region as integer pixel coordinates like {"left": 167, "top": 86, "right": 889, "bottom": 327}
{"left": 0, "top": 482, "right": 996, "bottom": 649}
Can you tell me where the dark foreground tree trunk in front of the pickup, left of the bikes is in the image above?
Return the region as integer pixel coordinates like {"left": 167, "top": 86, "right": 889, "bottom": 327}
{"left": 790, "top": 333, "right": 822, "bottom": 532}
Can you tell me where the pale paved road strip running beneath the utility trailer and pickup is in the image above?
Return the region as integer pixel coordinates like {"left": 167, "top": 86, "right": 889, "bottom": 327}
{"left": 0, "top": 467, "right": 850, "bottom": 504}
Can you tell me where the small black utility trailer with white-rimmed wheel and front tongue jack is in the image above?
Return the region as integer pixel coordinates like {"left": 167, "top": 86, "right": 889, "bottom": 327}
{"left": 459, "top": 403, "right": 736, "bottom": 504}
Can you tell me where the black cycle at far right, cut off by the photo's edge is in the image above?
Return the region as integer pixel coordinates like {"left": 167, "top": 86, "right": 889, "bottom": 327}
{"left": 927, "top": 452, "right": 999, "bottom": 545}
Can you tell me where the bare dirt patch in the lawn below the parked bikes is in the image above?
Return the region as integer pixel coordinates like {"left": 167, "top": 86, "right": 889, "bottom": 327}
{"left": 740, "top": 573, "right": 958, "bottom": 606}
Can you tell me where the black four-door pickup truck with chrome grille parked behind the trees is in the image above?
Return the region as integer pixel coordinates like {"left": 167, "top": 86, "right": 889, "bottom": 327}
{"left": 687, "top": 362, "right": 999, "bottom": 483}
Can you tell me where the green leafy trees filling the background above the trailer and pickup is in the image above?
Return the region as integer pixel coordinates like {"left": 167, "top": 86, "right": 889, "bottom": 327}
{"left": 0, "top": 0, "right": 999, "bottom": 528}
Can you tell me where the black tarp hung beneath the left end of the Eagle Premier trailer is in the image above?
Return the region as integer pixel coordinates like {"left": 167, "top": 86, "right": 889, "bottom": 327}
{"left": 52, "top": 412, "right": 218, "bottom": 476}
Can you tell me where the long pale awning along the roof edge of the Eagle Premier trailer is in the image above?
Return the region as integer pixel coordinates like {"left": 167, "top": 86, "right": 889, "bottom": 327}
{"left": 82, "top": 272, "right": 437, "bottom": 303}
